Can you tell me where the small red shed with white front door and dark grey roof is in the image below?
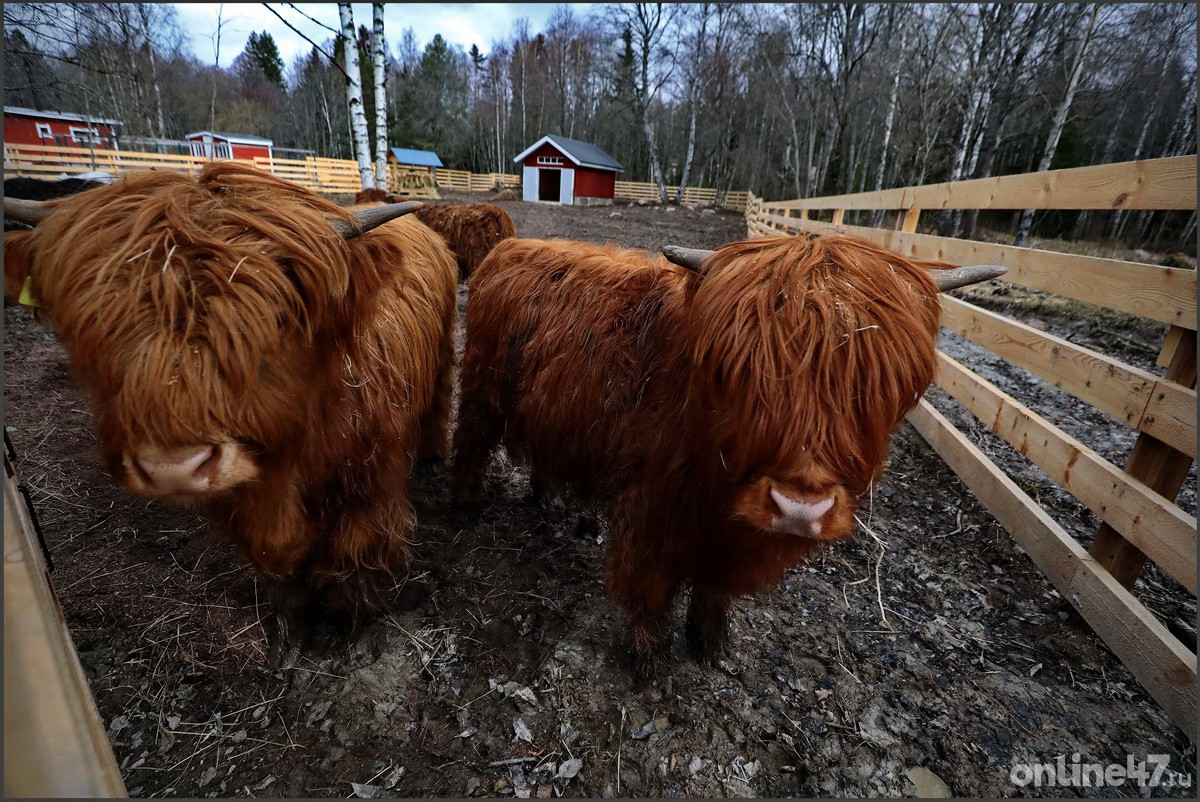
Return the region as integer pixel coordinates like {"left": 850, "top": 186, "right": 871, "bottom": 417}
{"left": 512, "top": 133, "right": 625, "bottom": 207}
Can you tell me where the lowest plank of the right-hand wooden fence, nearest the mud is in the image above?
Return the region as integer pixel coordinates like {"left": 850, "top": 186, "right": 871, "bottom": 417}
{"left": 908, "top": 400, "right": 1196, "bottom": 737}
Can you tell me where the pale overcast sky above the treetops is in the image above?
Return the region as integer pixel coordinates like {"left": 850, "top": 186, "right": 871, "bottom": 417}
{"left": 175, "top": 2, "right": 593, "bottom": 67}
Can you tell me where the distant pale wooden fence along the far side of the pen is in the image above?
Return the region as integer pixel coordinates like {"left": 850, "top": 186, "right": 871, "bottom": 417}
{"left": 4, "top": 143, "right": 750, "bottom": 211}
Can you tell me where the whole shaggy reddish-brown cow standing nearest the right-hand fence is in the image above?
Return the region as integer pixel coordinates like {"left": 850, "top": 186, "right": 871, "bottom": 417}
{"left": 455, "top": 237, "right": 1003, "bottom": 675}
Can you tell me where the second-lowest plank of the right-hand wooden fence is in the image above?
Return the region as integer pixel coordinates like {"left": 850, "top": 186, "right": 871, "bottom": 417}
{"left": 937, "top": 353, "right": 1196, "bottom": 593}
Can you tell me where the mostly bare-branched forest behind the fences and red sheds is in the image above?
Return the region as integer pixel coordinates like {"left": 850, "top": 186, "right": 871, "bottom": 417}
{"left": 4, "top": 2, "right": 1196, "bottom": 248}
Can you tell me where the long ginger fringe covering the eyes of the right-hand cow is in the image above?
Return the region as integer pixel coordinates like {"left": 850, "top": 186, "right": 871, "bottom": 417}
{"left": 689, "top": 237, "right": 940, "bottom": 492}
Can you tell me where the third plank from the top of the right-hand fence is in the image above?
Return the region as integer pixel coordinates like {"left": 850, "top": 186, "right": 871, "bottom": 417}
{"left": 940, "top": 293, "right": 1196, "bottom": 456}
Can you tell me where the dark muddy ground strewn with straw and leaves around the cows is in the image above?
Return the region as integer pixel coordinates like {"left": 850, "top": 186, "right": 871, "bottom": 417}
{"left": 4, "top": 193, "right": 1195, "bottom": 797}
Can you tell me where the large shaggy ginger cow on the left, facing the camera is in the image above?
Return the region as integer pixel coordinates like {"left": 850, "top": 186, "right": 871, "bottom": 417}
{"left": 5, "top": 162, "right": 456, "bottom": 660}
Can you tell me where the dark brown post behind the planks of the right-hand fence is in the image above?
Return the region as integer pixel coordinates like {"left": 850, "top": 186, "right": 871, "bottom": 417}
{"left": 1091, "top": 327, "right": 1196, "bottom": 587}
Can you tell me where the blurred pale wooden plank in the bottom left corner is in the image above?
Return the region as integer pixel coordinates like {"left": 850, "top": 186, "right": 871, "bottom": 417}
{"left": 4, "top": 457, "right": 127, "bottom": 800}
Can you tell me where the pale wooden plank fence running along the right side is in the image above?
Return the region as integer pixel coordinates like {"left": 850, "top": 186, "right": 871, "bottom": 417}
{"left": 746, "top": 155, "right": 1196, "bottom": 736}
